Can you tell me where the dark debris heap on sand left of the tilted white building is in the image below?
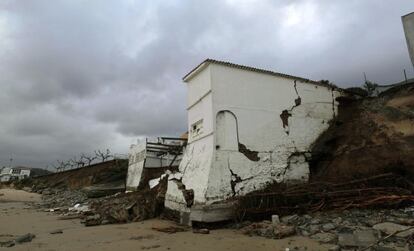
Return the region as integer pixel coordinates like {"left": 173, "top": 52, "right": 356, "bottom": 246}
{"left": 29, "top": 178, "right": 167, "bottom": 226}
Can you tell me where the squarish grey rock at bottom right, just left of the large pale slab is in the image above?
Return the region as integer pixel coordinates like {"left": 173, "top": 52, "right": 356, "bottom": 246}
{"left": 338, "top": 230, "right": 377, "bottom": 247}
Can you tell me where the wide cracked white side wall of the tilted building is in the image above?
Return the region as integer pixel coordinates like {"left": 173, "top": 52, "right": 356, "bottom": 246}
{"left": 205, "top": 65, "right": 339, "bottom": 203}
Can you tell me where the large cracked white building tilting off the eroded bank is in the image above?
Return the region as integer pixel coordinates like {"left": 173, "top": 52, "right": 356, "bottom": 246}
{"left": 165, "top": 59, "right": 341, "bottom": 223}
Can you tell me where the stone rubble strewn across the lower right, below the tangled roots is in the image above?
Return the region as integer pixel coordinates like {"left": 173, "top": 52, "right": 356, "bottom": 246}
{"left": 236, "top": 207, "right": 414, "bottom": 251}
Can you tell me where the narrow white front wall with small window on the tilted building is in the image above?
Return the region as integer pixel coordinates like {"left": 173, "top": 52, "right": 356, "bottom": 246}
{"left": 165, "top": 66, "right": 214, "bottom": 208}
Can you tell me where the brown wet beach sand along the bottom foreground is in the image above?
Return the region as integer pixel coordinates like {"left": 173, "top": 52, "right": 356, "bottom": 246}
{"left": 0, "top": 189, "right": 331, "bottom": 251}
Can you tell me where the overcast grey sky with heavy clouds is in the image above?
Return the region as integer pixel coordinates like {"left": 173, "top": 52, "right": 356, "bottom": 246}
{"left": 0, "top": 0, "right": 414, "bottom": 167}
